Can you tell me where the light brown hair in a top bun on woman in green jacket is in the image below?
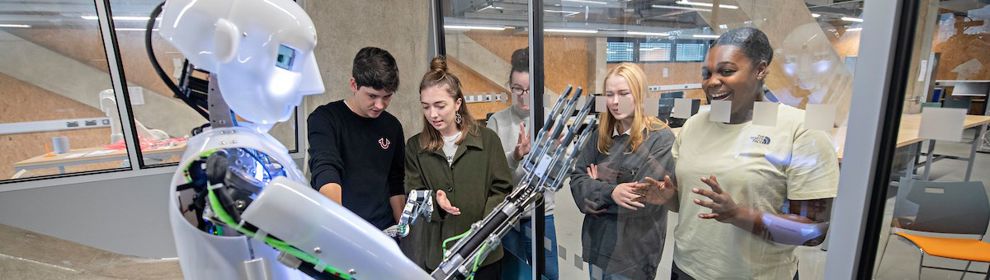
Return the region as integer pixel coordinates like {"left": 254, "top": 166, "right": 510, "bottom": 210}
{"left": 419, "top": 56, "right": 478, "bottom": 152}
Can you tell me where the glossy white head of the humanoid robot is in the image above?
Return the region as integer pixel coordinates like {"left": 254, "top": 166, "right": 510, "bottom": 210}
{"left": 159, "top": 0, "right": 323, "bottom": 130}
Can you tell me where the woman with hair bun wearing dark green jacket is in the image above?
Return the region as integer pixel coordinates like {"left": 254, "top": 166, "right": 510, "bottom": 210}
{"left": 402, "top": 57, "right": 512, "bottom": 279}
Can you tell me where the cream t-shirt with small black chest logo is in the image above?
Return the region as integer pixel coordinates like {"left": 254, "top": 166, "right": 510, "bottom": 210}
{"left": 672, "top": 105, "right": 839, "bottom": 279}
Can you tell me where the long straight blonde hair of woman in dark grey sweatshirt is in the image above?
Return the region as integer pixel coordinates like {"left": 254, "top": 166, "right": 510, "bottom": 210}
{"left": 598, "top": 63, "right": 667, "bottom": 154}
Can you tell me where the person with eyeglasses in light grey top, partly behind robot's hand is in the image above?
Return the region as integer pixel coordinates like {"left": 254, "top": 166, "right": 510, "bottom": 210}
{"left": 488, "top": 48, "right": 558, "bottom": 279}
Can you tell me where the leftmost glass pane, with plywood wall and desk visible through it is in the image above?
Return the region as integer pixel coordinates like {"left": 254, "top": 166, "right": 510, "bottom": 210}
{"left": 0, "top": 1, "right": 132, "bottom": 182}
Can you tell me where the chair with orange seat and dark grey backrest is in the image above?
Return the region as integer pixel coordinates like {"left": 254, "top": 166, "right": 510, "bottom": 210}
{"left": 877, "top": 178, "right": 990, "bottom": 279}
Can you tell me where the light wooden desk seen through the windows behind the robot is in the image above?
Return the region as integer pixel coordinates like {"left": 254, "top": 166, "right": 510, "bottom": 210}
{"left": 13, "top": 141, "right": 186, "bottom": 179}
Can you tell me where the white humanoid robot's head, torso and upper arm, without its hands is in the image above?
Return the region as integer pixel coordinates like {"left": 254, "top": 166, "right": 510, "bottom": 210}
{"left": 158, "top": 0, "right": 429, "bottom": 279}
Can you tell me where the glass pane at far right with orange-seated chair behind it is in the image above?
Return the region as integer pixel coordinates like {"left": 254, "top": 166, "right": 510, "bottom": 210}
{"left": 863, "top": 1, "right": 990, "bottom": 279}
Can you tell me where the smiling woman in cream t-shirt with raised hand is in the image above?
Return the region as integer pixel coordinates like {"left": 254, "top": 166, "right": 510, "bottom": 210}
{"left": 671, "top": 28, "right": 839, "bottom": 279}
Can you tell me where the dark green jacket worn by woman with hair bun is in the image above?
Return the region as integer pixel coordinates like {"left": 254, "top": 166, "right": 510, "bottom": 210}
{"left": 401, "top": 127, "right": 512, "bottom": 271}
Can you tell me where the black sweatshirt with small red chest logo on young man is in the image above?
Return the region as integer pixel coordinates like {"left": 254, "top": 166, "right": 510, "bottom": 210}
{"left": 306, "top": 100, "right": 405, "bottom": 229}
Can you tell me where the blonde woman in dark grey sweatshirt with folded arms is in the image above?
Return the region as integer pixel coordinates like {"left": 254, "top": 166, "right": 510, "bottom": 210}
{"left": 570, "top": 63, "right": 674, "bottom": 279}
